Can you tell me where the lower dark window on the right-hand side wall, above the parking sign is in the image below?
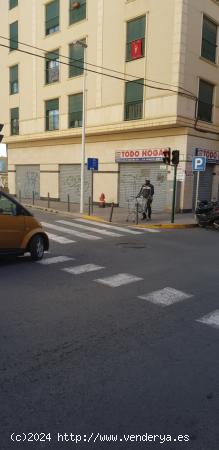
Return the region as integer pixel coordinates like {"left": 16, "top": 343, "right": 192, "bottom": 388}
{"left": 198, "top": 80, "right": 214, "bottom": 122}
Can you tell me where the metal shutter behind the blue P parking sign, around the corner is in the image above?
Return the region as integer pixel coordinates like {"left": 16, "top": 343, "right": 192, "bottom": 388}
{"left": 193, "top": 164, "right": 214, "bottom": 209}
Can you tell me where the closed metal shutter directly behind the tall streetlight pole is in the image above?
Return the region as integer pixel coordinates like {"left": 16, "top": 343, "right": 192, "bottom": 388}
{"left": 59, "top": 164, "right": 91, "bottom": 204}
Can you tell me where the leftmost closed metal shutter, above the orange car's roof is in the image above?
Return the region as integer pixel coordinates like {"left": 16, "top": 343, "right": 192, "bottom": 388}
{"left": 16, "top": 165, "right": 40, "bottom": 198}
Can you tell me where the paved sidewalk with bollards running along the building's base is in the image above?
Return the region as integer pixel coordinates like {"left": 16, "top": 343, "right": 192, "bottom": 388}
{"left": 22, "top": 199, "right": 196, "bottom": 228}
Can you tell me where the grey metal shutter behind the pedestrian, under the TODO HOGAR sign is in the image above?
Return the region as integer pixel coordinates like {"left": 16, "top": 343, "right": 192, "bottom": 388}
{"left": 119, "top": 163, "right": 169, "bottom": 211}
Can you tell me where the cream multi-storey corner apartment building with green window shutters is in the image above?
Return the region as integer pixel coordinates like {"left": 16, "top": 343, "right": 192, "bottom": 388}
{"left": 0, "top": 0, "right": 219, "bottom": 211}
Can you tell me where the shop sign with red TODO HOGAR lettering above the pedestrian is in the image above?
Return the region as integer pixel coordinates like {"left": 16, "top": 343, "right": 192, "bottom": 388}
{"left": 116, "top": 148, "right": 169, "bottom": 163}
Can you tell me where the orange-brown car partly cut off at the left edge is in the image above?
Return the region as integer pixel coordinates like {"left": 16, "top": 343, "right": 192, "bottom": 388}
{"left": 0, "top": 190, "right": 49, "bottom": 261}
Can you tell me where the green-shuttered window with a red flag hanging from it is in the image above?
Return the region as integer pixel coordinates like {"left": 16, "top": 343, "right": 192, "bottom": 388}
{"left": 126, "top": 16, "right": 145, "bottom": 61}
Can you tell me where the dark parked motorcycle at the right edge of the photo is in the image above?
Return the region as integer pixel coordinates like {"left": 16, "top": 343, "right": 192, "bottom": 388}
{"left": 195, "top": 201, "right": 219, "bottom": 230}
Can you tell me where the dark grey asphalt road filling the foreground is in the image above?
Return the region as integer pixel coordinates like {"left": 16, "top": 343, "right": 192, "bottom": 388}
{"left": 0, "top": 209, "right": 219, "bottom": 450}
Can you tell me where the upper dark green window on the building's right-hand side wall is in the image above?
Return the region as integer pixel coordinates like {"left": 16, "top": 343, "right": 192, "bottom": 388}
{"left": 201, "top": 17, "right": 217, "bottom": 62}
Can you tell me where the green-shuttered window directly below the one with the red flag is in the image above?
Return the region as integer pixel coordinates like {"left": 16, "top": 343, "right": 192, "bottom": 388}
{"left": 125, "top": 79, "right": 144, "bottom": 120}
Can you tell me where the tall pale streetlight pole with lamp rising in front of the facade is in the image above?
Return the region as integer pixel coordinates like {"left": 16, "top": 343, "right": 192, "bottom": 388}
{"left": 75, "top": 41, "right": 87, "bottom": 214}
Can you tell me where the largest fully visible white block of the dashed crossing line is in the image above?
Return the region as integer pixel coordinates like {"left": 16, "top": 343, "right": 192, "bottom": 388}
{"left": 138, "top": 287, "right": 193, "bottom": 306}
